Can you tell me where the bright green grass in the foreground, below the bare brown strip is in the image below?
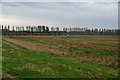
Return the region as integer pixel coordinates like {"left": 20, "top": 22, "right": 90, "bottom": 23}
{"left": 3, "top": 41, "right": 117, "bottom": 78}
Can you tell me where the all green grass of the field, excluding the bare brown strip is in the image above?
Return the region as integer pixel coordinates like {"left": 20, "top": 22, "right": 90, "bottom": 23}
{"left": 2, "top": 35, "right": 118, "bottom": 78}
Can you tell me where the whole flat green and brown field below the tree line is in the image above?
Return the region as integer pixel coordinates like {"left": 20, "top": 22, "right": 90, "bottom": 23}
{"left": 2, "top": 35, "right": 119, "bottom": 78}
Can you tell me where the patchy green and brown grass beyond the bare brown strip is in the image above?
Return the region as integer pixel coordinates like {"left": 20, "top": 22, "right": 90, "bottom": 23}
{"left": 10, "top": 35, "right": 118, "bottom": 56}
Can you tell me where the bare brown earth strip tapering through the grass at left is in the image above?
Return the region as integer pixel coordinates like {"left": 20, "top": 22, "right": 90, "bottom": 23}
{"left": 4, "top": 38, "right": 67, "bottom": 54}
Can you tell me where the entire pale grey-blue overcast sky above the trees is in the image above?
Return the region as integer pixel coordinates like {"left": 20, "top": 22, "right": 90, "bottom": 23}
{"left": 0, "top": 1, "right": 118, "bottom": 29}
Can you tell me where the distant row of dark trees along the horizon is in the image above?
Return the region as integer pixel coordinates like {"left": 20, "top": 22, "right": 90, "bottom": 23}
{"left": 0, "top": 25, "right": 120, "bottom": 35}
